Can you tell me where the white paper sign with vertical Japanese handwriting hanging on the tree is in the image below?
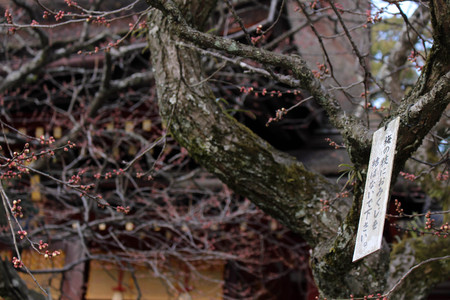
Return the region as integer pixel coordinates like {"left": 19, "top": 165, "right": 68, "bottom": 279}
{"left": 353, "top": 117, "right": 400, "bottom": 261}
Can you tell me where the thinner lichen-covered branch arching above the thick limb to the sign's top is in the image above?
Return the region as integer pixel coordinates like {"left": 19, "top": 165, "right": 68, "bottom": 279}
{"left": 147, "top": 0, "right": 370, "bottom": 164}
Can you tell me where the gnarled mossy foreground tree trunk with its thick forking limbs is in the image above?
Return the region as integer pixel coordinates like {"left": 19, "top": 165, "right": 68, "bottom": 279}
{"left": 147, "top": 0, "right": 450, "bottom": 299}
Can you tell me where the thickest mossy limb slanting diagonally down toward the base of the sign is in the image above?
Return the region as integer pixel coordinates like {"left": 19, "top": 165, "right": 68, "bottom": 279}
{"left": 149, "top": 1, "right": 352, "bottom": 245}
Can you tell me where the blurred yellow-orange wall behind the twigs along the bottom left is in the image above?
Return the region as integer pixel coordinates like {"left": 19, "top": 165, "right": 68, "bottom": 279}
{"left": 0, "top": 250, "right": 224, "bottom": 300}
